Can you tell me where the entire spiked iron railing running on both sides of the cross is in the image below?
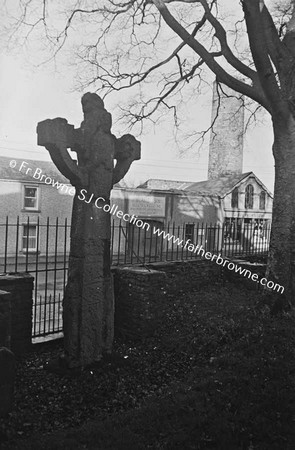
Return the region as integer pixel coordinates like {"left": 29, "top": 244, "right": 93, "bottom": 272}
{"left": 0, "top": 217, "right": 270, "bottom": 337}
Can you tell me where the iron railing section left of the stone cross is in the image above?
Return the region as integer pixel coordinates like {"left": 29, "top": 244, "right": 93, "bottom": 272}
{"left": 0, "top": 217, "right": 70, "bottom": 337}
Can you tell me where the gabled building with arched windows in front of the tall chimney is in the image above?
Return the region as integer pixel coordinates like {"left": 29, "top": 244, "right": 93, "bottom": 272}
{"left": 138, "top": 172, "right": 273, "bottom": 229}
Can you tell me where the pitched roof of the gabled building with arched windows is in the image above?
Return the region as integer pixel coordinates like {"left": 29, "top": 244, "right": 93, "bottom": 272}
{"left": 184, "top": 172, "right": 272, "bottom": 198}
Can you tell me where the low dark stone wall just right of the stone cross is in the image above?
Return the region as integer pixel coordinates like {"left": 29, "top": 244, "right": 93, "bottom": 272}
{"left": 112, "top": 260, "right": 220, "bottom": 339}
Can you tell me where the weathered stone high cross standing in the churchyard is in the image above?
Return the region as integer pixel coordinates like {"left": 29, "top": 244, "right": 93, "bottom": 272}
{"left": 37, "top": 93, "right": 140, "bottom": 368}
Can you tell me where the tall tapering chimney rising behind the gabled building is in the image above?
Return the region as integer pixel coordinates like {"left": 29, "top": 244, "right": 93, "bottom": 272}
{"left": 208, "top": 81, "right": 244, "bottom": 180}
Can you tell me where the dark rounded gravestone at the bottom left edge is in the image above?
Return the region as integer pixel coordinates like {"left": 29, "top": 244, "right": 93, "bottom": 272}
{"left": 0, "top": 347, "right": 15, "bottom": 417}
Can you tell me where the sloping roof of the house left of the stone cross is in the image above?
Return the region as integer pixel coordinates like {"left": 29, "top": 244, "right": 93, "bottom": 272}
{"left": 0, "top": 156, "right": 70, "bottom": 184}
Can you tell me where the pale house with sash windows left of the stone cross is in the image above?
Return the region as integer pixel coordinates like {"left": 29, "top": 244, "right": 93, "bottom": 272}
{"left": 0, "top": 156, "right": 73, "bottom": 255}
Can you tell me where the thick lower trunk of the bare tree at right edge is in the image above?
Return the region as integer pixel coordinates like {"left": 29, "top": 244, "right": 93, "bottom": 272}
{"left": 266, "top": 114, "right": 295, "bottom": 308}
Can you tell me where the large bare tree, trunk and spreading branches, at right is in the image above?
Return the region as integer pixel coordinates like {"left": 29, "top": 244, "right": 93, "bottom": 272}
{"left": 4, "top": 0, "right": 295, "bottom": 303}
